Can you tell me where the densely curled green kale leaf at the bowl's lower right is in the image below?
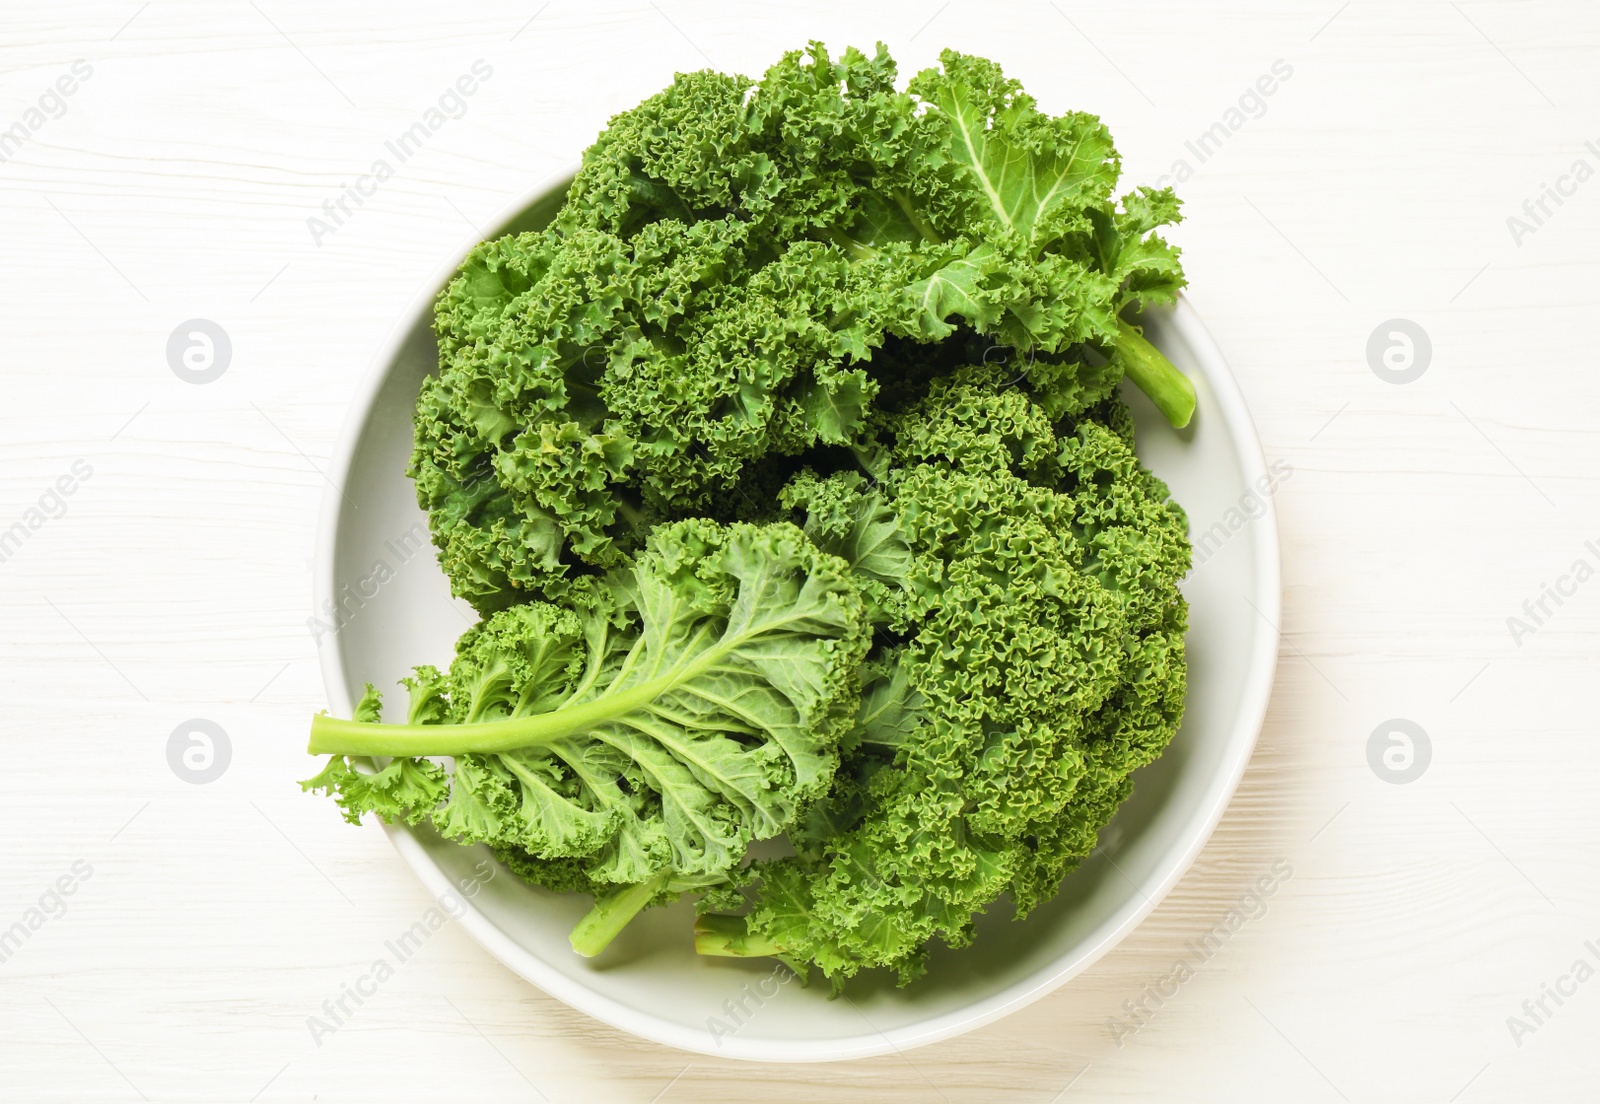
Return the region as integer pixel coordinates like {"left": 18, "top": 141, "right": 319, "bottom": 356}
{"left": 699, "top": 370, "right": 1189, "bottom": 984}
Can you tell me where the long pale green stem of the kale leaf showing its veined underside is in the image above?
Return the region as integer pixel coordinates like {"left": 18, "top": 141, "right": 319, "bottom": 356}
{"left": 306, "top": 659, "right": 722, "bottom": 757}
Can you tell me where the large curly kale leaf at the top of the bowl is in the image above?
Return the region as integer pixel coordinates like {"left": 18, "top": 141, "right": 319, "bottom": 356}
{"left": 411, "top": 43, "right": 1194, "bottom": 611}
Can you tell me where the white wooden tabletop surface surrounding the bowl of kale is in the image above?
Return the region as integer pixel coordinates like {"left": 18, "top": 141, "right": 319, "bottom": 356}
{"left": 0, "top": 0, "right": 1600, "bottom": 1104}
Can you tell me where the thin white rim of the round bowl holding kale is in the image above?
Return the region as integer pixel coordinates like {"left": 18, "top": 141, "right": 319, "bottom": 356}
{"left": 312, "top": 172, "right": 1282, "bottom": 1062}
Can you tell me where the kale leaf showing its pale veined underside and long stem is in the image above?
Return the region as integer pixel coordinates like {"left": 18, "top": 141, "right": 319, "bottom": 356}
{"left": 304, "top": 520, "right": 869, "bottom": 947}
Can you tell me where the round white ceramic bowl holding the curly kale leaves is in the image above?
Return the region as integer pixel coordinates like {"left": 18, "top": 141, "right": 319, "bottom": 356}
{"left": 315, "top": 172, "right": 1278, "bottom": 1061}
